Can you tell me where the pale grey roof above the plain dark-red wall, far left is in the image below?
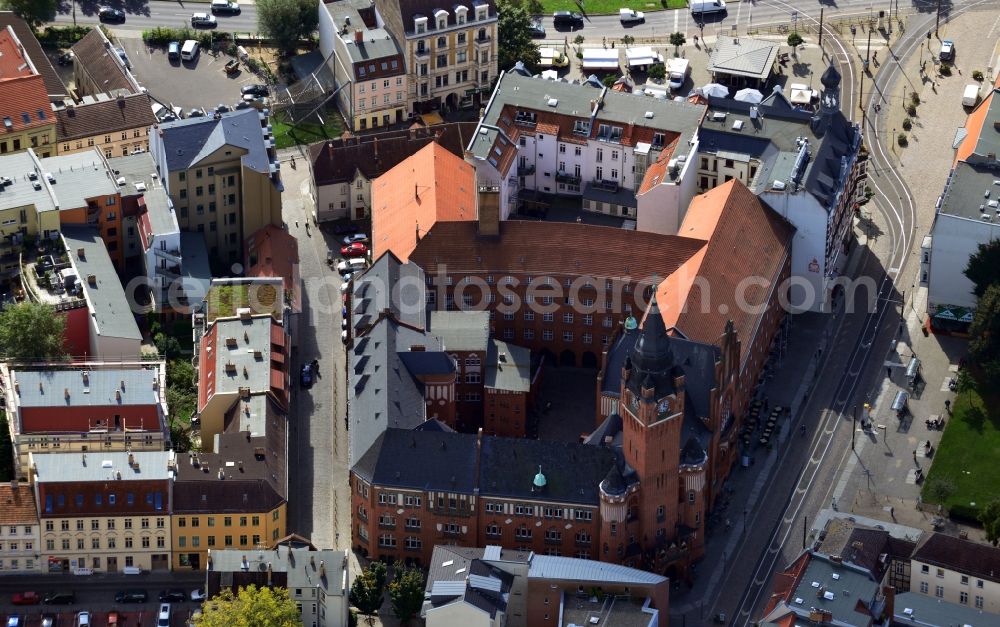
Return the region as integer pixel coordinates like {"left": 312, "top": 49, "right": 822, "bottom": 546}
{"left": 11, "top": 362, "right": 160, "bottom": 407}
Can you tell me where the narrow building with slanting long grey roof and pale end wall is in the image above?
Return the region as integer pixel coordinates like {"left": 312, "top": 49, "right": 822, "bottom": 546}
{"left": 61, "top": 225, "right": 142, "bottom": 361}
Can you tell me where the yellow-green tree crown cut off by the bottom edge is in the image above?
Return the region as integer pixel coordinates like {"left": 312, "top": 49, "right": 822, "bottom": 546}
{"left": 195, "top": 585, "right": 302, "bottom": 627}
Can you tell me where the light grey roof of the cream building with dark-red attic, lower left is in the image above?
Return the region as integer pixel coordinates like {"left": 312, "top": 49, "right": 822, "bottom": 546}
{"left": 31, "top": 451, "right": 174, "bottom": 483}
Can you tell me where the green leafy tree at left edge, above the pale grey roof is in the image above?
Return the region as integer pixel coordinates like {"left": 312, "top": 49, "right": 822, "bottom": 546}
{"left": 0, "top": 301, "right": 66, "bottom": 362}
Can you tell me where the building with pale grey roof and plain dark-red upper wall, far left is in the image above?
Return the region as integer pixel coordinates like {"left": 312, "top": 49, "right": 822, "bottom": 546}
{"left": 0, "top": 361, "right": 170, "bottom": 477}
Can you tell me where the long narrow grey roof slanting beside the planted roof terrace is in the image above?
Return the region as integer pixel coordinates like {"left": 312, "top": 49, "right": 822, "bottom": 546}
{"left": 61, "top": 225, "right": 142, "bottom": 340}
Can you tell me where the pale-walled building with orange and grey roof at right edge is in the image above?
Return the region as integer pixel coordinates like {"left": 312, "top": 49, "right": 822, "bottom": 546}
{"left": 920, "top": 87, "right": 1000, "bottom": 332}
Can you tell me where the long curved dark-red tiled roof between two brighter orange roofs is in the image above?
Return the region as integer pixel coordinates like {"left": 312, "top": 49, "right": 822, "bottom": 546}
{"left": 410, "top": 220, "right": 704, "bottom": 282}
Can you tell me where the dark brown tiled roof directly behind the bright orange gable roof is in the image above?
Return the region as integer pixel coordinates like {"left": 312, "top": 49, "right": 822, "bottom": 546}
{"left": 309, "top": 122, "right": 476, "bottom": 187}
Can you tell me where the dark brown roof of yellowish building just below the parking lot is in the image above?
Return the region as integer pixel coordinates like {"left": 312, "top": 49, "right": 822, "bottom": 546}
{"left": 55, "top": 94, "right": 156, "bottom": 141}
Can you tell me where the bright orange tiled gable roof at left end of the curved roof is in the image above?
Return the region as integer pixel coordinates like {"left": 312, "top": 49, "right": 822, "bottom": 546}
{"left": 372, "top": 142, "right": 476, "bottom": 262}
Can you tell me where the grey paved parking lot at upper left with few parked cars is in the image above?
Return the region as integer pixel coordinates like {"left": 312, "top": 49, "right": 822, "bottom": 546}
{"left": 114, "top": 38, "right": 260, "bottom": 112}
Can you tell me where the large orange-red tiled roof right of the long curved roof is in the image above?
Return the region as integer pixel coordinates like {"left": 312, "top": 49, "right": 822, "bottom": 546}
{"left": 656, "top": 179, "right": 794, "bottom": 347}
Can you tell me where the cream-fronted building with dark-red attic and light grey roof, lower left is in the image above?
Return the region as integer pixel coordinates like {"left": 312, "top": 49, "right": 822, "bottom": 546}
{"left": 29, "top": 451, "right": 177, "bottom": 573}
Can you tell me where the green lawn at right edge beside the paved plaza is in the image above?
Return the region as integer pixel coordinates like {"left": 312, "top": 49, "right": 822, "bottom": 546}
{"left": 907, "top": 390, "right": 1000, "bottom": 518}
